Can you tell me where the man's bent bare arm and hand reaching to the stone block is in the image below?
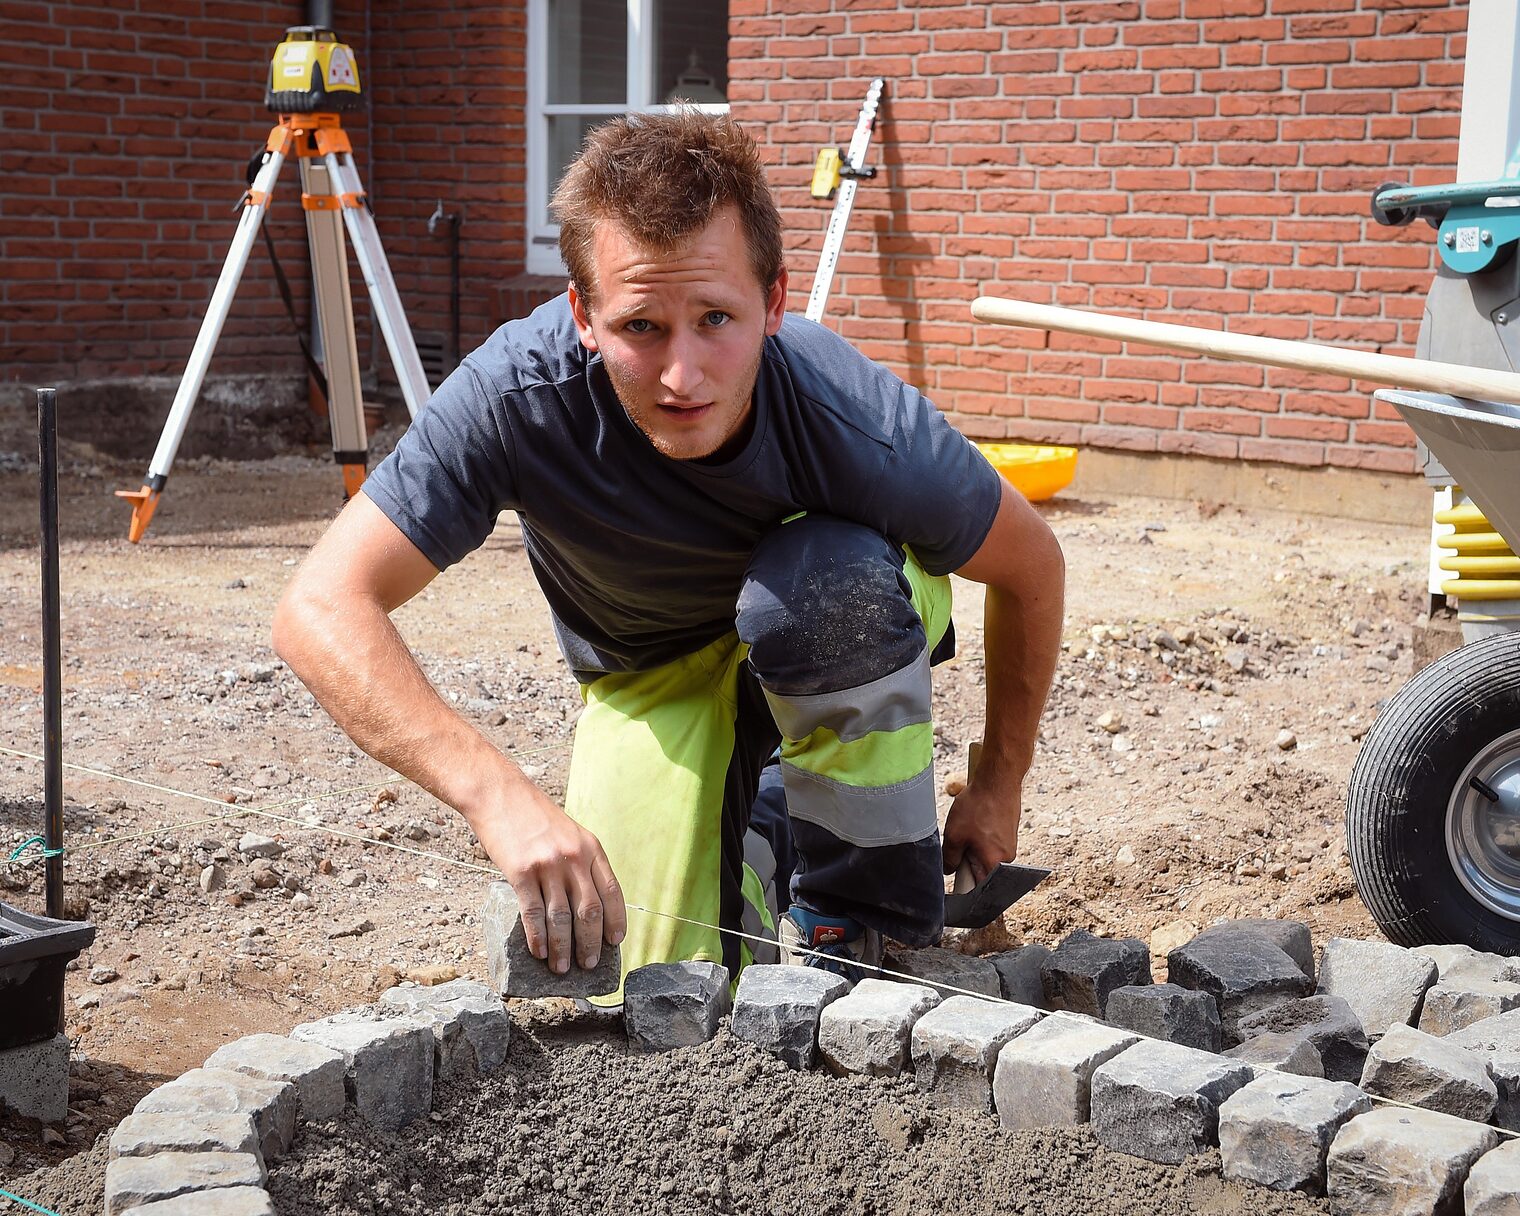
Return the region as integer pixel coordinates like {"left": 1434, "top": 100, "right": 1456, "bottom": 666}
{"left": 274, "top": 494, "right": 626, "bottom": 971}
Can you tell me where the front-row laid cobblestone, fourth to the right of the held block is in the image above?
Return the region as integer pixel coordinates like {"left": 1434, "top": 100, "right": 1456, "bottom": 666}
{"left": 910, "top": 996, "right": 1040, "bottom": 1114}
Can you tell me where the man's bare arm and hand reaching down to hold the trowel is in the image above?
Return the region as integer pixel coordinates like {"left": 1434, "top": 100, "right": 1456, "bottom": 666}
{"left": 944, "top": 482, "right": 1066, "bottom": 882}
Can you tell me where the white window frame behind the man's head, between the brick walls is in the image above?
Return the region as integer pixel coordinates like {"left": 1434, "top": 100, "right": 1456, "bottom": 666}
{"left": 524, "top": 0, "right": 728, "bottom": 275}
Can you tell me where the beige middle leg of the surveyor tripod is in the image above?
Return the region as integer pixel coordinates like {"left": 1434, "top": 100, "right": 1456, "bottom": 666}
{"left": 301, "top": 157, "right": 369, "bottom": 499}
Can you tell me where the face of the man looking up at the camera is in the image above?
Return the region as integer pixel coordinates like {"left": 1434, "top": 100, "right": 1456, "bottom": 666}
{"left": 570, "top": 207, "right": 786, "bottom": 461}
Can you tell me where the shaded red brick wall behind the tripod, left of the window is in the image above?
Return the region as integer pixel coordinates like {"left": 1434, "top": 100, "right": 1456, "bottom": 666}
{"left": 0, "top": 0, "right": 526, "bottom": 407}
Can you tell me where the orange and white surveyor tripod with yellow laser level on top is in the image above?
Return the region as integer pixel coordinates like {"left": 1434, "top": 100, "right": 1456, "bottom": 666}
{"left": 117, "top": 30, "right": 429, "bottom": 543}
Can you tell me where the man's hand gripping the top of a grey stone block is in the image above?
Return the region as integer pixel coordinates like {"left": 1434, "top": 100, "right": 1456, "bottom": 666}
{"left": 470, "top": 780, "right": 628, "bottom": 974}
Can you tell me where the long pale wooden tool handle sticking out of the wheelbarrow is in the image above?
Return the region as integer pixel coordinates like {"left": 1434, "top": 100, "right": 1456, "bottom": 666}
{"left": 971, "top": 295, "right": 1520, "bottom": 404}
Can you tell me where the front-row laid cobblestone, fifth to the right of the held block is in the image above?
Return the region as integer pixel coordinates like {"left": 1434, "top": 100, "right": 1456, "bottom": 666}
{"left": 993, "top": 1012, "right": 1140, "bottom": 1131}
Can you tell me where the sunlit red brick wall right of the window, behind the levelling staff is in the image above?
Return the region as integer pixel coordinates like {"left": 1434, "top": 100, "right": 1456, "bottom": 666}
{"left": 730, "top": 0, "right": 1467, "bottom": 471}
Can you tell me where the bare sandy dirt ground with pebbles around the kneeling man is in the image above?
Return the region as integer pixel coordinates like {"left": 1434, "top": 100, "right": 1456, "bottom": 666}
{"left": 0, "top": 444, "right": 1426, "bottom": 1211}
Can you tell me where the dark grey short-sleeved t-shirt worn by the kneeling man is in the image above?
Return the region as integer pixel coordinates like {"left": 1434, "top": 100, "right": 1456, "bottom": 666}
{"left": 363, "top": 296, "right": 1002, "bottom": 678}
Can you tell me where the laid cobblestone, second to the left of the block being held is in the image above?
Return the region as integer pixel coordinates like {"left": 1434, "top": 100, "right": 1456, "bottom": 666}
{"left": 290, "top": 1014, "right": 433, "bottom": 1131}
